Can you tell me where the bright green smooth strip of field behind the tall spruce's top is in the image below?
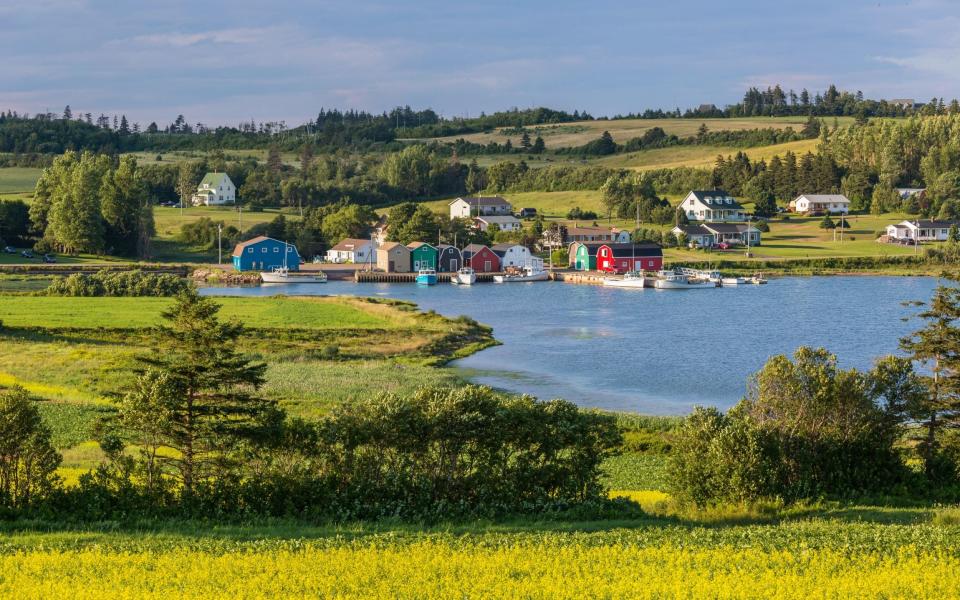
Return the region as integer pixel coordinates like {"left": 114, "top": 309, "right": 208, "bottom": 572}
{"left": 0, "top": 296, "right": 392, "bottom": 329}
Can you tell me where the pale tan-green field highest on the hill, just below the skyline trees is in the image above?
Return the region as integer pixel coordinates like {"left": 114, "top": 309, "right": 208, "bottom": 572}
{"left": 424, "top": 117, "right": 853, "bottom": 148}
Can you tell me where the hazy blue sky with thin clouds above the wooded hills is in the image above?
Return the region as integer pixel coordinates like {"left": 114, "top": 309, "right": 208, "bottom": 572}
{"left": 0, "top": 0, "right": 960, "bottom": 126}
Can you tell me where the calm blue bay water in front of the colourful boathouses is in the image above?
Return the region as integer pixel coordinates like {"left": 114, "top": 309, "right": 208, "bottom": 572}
{"left": 205, "top": 277, "right": 936, "bottom": 414}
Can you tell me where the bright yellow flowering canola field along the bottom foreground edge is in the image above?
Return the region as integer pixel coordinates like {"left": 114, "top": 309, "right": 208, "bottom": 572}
{"left": 0, "top": 540, "right": 960, "bottom": 600}
